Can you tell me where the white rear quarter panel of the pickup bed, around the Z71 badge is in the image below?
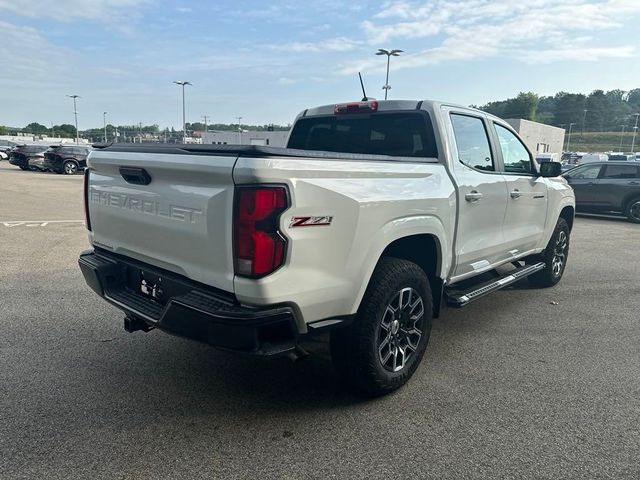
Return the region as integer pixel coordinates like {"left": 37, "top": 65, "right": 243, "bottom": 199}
{"left": 234, "top": 157, "right": 456, "bottom": 323}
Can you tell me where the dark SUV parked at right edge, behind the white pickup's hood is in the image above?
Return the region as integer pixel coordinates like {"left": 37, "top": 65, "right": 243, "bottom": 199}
{"left": 562, "top": 162, "right": 640, "bottom": 223}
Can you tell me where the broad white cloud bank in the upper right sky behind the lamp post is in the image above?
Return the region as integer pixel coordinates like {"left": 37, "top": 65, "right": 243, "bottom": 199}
{"left": 340, "top": 0, "right": 640, "bottom": 74}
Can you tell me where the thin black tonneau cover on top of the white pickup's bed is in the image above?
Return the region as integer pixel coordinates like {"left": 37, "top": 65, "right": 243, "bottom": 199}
{"left": 93, "top": 143, "right": 438, "bottom": 163}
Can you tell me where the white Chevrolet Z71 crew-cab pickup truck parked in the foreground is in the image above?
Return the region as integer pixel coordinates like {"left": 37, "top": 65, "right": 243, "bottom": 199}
{"left": 79, "top": 101, "right": 575, "bottom": 395}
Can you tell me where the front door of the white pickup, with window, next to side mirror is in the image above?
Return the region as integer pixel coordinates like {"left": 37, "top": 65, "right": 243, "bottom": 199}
{"left": 492, "top": 122, "right": 555, "bottom": 257}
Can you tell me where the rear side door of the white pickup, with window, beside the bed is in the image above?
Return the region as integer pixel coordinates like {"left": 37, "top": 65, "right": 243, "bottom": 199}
{"left": 444, "top": 108, "right": 507, "bottom": 281}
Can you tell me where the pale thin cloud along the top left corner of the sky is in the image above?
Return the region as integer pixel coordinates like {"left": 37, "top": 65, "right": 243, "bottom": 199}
{"left": 0, "top": 0, "right": 149, "bottom": 21}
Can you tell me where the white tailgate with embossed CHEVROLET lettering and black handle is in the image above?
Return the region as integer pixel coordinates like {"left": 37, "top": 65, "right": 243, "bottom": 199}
{"left": 87, "top": 150, "right": 237, "bottom": 292}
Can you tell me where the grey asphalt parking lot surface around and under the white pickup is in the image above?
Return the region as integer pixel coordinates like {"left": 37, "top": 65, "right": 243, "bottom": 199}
{"left": 0, "top": 162, "right": 640, "bottom": 479}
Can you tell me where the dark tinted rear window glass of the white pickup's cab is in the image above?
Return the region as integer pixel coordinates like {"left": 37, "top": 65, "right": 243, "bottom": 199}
{"left": 287, "top": 112, "right": 438, "bottom": 157}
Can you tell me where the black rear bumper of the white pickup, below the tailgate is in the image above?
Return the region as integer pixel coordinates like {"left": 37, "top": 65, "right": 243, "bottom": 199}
{"left": 78, "top": 250, "right": 298, "bottom": 355}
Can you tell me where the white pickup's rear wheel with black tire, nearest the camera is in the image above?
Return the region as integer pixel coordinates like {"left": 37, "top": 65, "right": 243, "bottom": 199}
{"left": 331, "top": 257, "right": 433, "bottom": 396}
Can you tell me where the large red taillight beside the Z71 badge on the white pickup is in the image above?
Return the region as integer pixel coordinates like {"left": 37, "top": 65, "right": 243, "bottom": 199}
{"left": 233, "top": 185, "right": 289, "bottom": 278}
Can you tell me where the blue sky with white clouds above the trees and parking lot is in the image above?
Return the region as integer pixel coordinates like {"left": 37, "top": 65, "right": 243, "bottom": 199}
{"left": 0, "top": 0, "right": 640, "bottom": 130}
